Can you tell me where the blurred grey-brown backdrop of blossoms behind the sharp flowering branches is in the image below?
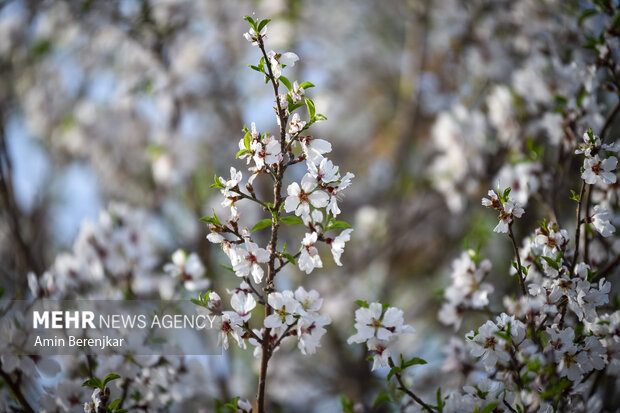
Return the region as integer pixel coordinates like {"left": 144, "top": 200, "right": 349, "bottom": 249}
{"left": 0, "top": 0, "right": 617, "bottom": 412}
